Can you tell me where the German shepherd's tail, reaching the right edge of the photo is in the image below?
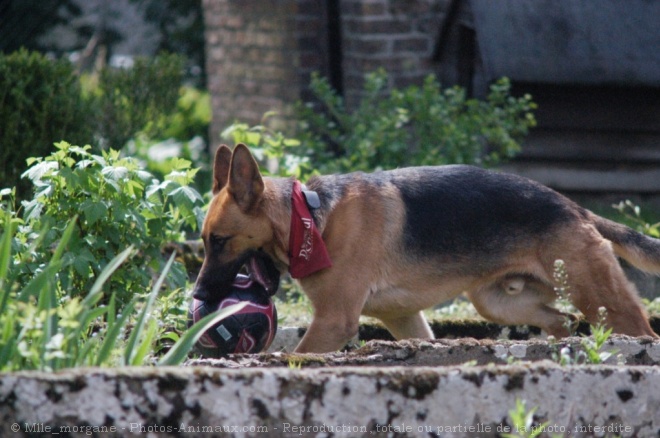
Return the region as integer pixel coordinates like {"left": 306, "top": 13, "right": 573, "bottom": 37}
{"left": 590, "top": 213, "right": 660, "bottom": 275}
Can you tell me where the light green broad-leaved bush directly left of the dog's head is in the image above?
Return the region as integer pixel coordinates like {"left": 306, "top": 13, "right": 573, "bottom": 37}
{"left": 9, "top": 142, "right": 203, "bottom": 306}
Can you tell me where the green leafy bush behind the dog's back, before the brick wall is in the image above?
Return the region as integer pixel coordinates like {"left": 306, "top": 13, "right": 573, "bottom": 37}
{"left": 295, "top": 70, "right": 535, "bottom": 173}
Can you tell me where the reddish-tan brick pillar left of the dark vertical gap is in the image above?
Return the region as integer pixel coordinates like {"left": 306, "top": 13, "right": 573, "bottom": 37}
{"left": 203, "top": 0, "right": 325, "bottom": 145}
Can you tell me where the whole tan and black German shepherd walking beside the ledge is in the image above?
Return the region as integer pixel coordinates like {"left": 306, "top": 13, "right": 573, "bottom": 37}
{"left": 194, "top": 144, "right": 660, "bottom": 352}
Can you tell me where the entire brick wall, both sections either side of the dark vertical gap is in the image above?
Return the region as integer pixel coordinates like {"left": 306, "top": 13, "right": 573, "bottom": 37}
{"left": 203, "top": 0, "right": 449, "bottom": 145}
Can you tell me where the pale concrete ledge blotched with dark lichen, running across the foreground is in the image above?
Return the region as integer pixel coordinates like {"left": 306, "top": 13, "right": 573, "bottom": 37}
{"left": 0, "top": 362, "right": 660, "bottom": 437}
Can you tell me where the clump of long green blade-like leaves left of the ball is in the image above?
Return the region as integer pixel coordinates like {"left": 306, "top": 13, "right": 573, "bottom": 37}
{"left": 0, "top": 218, "right": 242, "bottom": 372}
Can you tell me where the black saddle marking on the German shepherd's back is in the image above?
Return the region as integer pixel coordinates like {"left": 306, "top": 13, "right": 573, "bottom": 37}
{"left": 390, "top": 166, "right": 577, "bottom": 256}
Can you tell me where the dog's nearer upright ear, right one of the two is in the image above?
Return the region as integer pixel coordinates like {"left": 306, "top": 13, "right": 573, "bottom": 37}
{"left": 227, "top": 143, "right": 264, "bottom": 212}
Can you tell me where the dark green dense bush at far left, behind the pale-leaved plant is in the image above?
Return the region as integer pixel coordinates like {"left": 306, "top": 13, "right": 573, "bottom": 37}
{"left": 0, "top": 50, "right": 92, "bottom": 197}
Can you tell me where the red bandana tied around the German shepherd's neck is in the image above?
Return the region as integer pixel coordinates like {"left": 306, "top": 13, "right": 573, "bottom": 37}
{"left": 289, "top": 181, "right": 332, "bottom": 278}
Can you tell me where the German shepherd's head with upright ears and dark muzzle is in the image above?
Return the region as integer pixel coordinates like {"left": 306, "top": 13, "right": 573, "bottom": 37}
{"left": 193, "top": 144, "right": 279, "bottom": 300}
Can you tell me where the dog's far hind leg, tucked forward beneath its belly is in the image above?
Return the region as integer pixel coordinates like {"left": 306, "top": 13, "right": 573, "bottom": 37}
{"left": 468, "top": 277, "right": 575, "bottom": 337}
